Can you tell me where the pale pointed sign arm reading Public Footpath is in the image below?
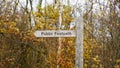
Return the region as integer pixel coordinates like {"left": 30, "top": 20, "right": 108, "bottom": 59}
{"left": 34, "top": 30, "right": 76, "bottom": 37}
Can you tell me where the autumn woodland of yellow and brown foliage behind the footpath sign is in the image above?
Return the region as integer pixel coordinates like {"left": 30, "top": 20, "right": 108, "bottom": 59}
{"left": 0, "top": 0, "right": 120, "bottom": 68}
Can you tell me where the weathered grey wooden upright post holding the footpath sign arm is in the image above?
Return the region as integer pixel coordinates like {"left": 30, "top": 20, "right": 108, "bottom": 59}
{"left": 76, "top": 16, "right": 84, "bottom": 68}
